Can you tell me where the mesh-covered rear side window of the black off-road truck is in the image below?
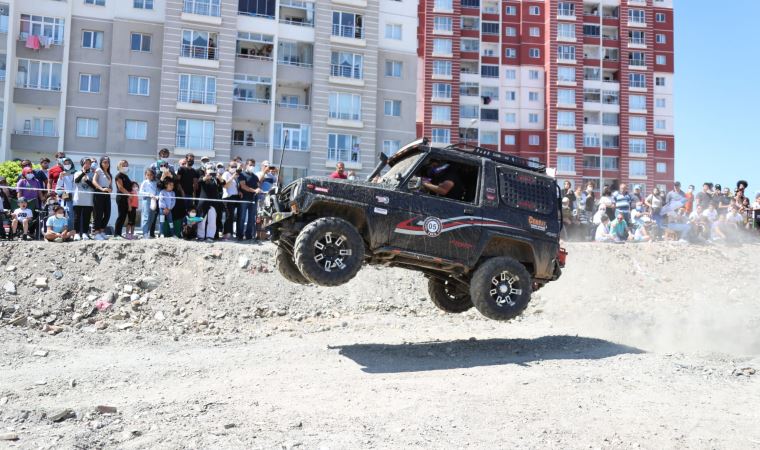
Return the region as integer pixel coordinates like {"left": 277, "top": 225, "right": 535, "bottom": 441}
{"left": 499, "top": 167, "right": 556, "bottom": 215}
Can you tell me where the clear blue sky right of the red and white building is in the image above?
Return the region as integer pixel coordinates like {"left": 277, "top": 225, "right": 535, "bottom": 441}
{"left": 674, "top": 0, "right": 760, "bottom": 194}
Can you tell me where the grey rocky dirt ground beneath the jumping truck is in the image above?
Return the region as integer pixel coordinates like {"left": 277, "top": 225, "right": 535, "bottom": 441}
{"left": 0, "top": 240, "right": 760, "bottom": 449}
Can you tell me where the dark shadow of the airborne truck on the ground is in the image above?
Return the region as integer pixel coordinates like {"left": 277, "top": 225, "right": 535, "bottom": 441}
{"left": 330, "top": 336, "right": 644, "bottom": 373}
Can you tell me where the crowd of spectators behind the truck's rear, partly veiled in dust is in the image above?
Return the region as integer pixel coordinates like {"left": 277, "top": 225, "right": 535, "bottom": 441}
{"left": 562, "top": 180, "right": 760, "bottom": 243}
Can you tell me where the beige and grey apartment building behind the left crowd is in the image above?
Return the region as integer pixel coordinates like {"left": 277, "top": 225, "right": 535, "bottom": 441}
{"left": 0, "top": 0, "right": 417, "bottom": 184}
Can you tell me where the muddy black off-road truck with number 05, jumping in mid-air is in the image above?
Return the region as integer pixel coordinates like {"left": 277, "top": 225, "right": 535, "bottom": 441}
{"left": 263, "top": 139, "right": 566, "bottom": 320}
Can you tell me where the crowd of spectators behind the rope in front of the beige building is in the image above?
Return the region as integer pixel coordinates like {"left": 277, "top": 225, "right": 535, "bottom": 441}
{"left": 0, "top": 149, "right": 278, "bottom": 242}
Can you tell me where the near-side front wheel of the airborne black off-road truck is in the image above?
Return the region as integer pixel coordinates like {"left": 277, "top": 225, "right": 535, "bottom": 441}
{"left": 293, "top": 217, "right": 364, "bottom": 286}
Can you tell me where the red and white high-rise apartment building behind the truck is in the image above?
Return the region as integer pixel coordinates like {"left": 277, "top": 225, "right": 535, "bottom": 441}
{"left": 417, "top": 0, "right": 674, "bottom": 191}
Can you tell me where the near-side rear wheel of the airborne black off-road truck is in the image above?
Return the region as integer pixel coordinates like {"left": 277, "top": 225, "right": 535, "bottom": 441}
{"left": 470, "top": 256, "right": 533, "bottom": 320}
